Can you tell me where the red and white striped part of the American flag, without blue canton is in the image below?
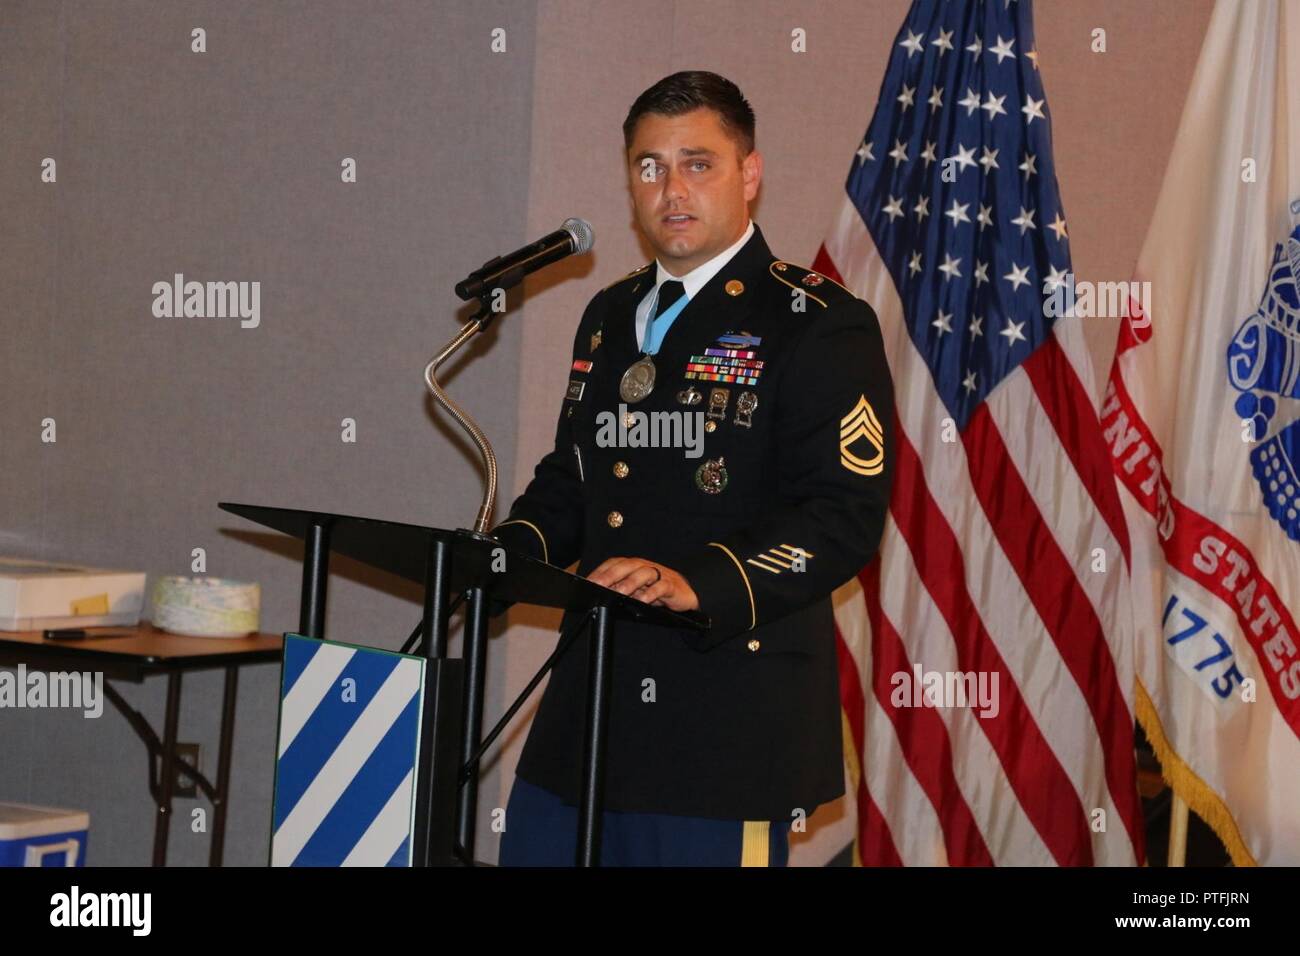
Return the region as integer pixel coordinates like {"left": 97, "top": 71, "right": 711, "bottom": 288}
{"left": 814, "top": 198, "right": 1144, "bottom": 865}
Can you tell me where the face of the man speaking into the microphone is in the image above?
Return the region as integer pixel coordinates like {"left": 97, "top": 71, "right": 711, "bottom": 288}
{"left": 628, "top": 108, "right": 763, "bottom": 276}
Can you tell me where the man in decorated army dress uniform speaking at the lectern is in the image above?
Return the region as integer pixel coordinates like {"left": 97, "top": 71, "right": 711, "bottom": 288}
{"left": 495, "top": 72, "right": 893, "bottom": 866}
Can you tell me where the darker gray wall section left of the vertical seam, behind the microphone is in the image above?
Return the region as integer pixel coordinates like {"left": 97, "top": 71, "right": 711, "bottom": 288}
{"left": 0, "top": 0, "right": 536, "bottom": 865}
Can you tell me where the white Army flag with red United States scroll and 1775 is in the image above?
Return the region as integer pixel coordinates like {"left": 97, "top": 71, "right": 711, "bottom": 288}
{"left": 1101, "top": 0, "right": 1300, "bottom": 865}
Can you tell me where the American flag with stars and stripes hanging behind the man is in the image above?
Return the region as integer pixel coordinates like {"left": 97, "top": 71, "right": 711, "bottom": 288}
{"left": 814, "top": 0, "right": 1144, "bottom": 865}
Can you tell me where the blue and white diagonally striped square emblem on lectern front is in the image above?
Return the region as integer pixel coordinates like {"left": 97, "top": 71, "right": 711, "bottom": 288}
{"left": 270, "top": 635, "right": 424, "bottom": 866}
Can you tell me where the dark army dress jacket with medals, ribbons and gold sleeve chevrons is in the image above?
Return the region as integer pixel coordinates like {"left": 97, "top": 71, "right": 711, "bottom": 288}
{"left": 494, "top": 225, "right": 894, "bottom": 821}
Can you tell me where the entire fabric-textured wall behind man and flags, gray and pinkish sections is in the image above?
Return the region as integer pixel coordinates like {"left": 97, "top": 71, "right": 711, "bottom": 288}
{"left": 0, "top": 0, "right": 1212, "bottom": 865}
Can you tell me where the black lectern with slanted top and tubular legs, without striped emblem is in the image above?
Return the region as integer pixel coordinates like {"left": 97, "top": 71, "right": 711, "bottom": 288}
{"left": 220, "top": 502, "right": 709, "bottom": 866}
